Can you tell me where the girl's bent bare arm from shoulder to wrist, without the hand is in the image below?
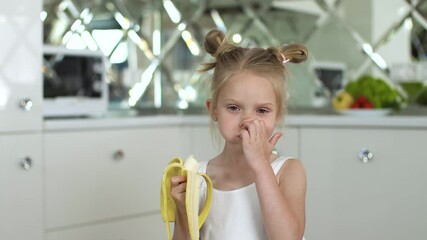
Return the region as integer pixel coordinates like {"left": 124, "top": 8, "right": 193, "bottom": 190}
{"left": 255, "top": 159, "right": 306, "bottom": 240}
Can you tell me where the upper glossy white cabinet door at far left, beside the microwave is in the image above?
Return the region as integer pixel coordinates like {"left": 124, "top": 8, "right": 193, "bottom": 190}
{"left": 0, "top": 0, "right": 42, "bottom": 132}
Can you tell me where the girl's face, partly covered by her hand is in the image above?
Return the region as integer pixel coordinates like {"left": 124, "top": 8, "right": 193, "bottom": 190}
{"left": 212, "top": 72, "right": 278, "bottom": 143}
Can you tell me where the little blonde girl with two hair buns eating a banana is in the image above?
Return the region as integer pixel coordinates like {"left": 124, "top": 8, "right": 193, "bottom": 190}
{"left": 171, "top": 30, "right": 307, "bottom": 240}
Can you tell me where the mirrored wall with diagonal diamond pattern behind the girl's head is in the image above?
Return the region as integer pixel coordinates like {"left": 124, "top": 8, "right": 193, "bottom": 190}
{"left": 41, "top": 0, "right": 427, "bottom": 112}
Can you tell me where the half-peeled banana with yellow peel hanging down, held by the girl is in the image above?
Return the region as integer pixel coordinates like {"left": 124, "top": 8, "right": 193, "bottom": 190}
{"left": 160, "top": 156, "right": 213, "bottom": 240}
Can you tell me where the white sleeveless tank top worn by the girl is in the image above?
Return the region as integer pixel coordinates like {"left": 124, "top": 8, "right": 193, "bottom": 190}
{"left": 200, "top": 157, "right": 290, "bottom": 240}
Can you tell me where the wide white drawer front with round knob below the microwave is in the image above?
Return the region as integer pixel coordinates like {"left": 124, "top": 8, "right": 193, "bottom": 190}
{"left": 44, "top": 127, "right": 189, "bottom": 233}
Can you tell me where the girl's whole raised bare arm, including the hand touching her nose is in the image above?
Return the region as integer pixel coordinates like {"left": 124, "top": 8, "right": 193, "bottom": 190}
{"left": 241, "top": 120, "right": 306, "bottom": 240}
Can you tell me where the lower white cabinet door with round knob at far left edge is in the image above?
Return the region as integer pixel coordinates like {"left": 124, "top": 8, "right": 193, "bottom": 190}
{"left": 0, "top": 134, "right": 43, "bottom": 240}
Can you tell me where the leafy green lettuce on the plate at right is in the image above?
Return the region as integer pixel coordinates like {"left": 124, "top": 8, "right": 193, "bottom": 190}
{"left": 344, "top": 75, "right": 406, "bottom": 110}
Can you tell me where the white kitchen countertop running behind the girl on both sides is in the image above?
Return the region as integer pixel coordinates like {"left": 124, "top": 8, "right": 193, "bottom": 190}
{"left": 44, "top": 106, "right": 427, "bottom": 132}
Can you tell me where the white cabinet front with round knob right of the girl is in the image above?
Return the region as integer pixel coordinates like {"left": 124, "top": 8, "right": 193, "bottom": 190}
{"left": 301, "top": 129, "right": 427, "bottom": 240}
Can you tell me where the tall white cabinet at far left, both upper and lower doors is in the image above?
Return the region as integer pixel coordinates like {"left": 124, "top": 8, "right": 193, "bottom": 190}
{"left": 0, "top": 0, "right": 44, "bottom": 240}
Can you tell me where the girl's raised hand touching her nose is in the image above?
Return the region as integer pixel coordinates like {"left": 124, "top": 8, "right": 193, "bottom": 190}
{"left": 241, "top": 119, "right": 282, "bottom": 173}
